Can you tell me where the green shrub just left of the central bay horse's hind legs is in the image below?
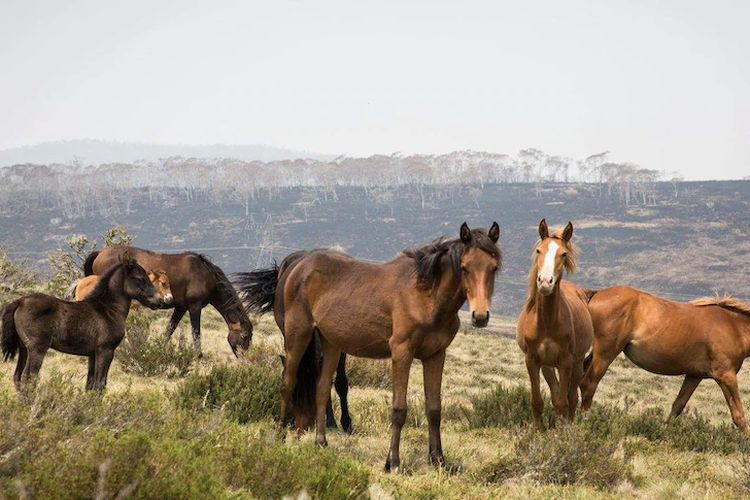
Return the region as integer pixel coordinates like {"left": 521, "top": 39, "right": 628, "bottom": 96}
{"left": 174, "top": 364, "right": 281, "bottom": 423}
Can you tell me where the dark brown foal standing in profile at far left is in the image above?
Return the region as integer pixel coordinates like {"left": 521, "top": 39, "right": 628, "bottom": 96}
{"left": 0, "top": 254, "right": 161, "bottom": 391}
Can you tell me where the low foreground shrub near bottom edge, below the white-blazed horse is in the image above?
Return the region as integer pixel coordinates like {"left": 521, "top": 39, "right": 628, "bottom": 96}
{"left": 484, "top": 425, "right": 632, "bottom": 489}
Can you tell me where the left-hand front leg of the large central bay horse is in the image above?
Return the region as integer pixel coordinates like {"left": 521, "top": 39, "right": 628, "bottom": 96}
{"left": 385, "top": 343, "right": 414, "bottom": 473}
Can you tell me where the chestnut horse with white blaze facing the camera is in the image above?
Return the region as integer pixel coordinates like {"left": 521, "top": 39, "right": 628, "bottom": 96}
{"left": 516, "top": 219, "right": 593, "bottom": 429}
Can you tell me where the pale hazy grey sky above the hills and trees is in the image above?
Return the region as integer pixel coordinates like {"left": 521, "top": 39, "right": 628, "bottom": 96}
{"left": 0, "top": 0, "right": 750, "bottom": 178}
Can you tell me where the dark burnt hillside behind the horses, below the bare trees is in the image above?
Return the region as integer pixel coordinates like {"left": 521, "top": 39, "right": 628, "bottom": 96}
{"left": 0, "top": 181, "right": 750, "bottom": 315}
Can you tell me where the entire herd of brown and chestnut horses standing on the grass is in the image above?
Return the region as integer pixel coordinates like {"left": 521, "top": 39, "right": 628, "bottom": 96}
{"left": 0, "top": 219, "right": 750, "bottom": 472}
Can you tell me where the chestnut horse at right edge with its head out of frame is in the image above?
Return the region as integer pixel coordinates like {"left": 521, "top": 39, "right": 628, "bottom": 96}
{"left": 581, "top": 286, "right": 750, "bottom": 435}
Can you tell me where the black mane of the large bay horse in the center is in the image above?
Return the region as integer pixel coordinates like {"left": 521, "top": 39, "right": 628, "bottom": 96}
{"left": 404, "top": 229, "right": 503, "bottom": 290}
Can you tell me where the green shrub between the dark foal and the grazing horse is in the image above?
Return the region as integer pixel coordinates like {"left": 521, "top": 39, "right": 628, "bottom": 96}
{"left": 115, "top": 311, "right": 197, "bottom": 378}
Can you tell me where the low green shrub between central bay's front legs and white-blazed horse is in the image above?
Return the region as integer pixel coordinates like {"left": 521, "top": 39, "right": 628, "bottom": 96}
{"left": 467, "top": 385, "right": 555, "bottom": 428}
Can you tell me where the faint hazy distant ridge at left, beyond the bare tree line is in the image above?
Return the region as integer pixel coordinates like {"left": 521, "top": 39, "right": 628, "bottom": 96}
{"left": 0, "top": 139, "right": 335, "bottom": 167}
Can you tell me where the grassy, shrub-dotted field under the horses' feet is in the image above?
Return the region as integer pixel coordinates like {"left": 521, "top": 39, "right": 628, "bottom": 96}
{"left": 0, "top": 309, "right": 750, "bottom": 498}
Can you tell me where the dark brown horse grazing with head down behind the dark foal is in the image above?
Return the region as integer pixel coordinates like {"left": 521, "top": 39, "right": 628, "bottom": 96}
{"left": 83, "top": 246, "right": 253, "bottom": 356}
